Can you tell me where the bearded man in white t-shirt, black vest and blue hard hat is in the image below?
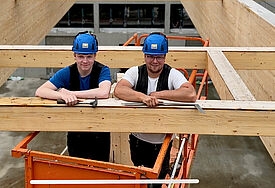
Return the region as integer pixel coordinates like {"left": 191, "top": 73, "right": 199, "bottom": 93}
{"left": 114, "top": 33, "right": 196, "bottom": 185}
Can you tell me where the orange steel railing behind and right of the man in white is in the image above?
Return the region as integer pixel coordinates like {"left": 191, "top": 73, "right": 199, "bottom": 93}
{"left": 123, "top": 33, "right": 209, "bottom": 188}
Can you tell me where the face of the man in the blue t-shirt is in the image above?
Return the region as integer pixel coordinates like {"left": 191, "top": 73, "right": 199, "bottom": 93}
{"left": 74, "top": 53, "right": 96, "bottom": 72}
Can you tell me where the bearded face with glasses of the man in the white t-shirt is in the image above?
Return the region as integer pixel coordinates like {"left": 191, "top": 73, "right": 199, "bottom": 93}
{"left": 144, "top": 54, "right": 165, "bottom": 76}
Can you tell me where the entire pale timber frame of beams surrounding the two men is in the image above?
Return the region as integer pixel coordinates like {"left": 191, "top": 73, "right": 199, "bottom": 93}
{"left": 0, "top": 0, "right": 275, "bottom": 185}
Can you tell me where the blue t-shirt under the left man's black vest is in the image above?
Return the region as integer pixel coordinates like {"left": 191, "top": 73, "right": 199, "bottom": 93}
{"left": 50, "top": 66, "right": 111, "bottom": 91}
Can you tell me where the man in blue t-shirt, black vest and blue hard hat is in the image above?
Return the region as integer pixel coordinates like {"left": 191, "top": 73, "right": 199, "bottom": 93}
{"left": 35, "top": 32, "right": 111, "bottom": 161}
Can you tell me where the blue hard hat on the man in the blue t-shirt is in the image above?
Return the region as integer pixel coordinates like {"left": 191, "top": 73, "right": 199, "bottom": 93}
{"left": 72, "top": 32, "right": 98, "bottom": 54}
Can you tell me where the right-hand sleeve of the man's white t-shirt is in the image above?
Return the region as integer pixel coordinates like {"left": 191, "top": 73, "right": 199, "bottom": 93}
{"left": 168, "top": 68, "right": 188, "bottom": 89}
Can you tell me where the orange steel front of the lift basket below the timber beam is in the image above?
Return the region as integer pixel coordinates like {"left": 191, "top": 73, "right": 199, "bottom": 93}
{"left": 12, "top": 132, "right": 172, "bottom": 188}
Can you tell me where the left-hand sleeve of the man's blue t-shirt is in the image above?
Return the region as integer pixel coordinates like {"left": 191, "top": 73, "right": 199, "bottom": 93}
{"left": 50, "top": 67, "right": 70, "bottom": 89}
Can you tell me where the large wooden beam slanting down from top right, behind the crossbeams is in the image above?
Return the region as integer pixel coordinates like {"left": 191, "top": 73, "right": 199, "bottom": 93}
{"left": 181, "top": 0, "right": 275, "bottom": 161}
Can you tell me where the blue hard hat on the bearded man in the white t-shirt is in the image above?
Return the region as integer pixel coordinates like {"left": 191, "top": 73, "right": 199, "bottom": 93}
{"left": 142, "top": 33, "right": 168, "bottom": 55}
